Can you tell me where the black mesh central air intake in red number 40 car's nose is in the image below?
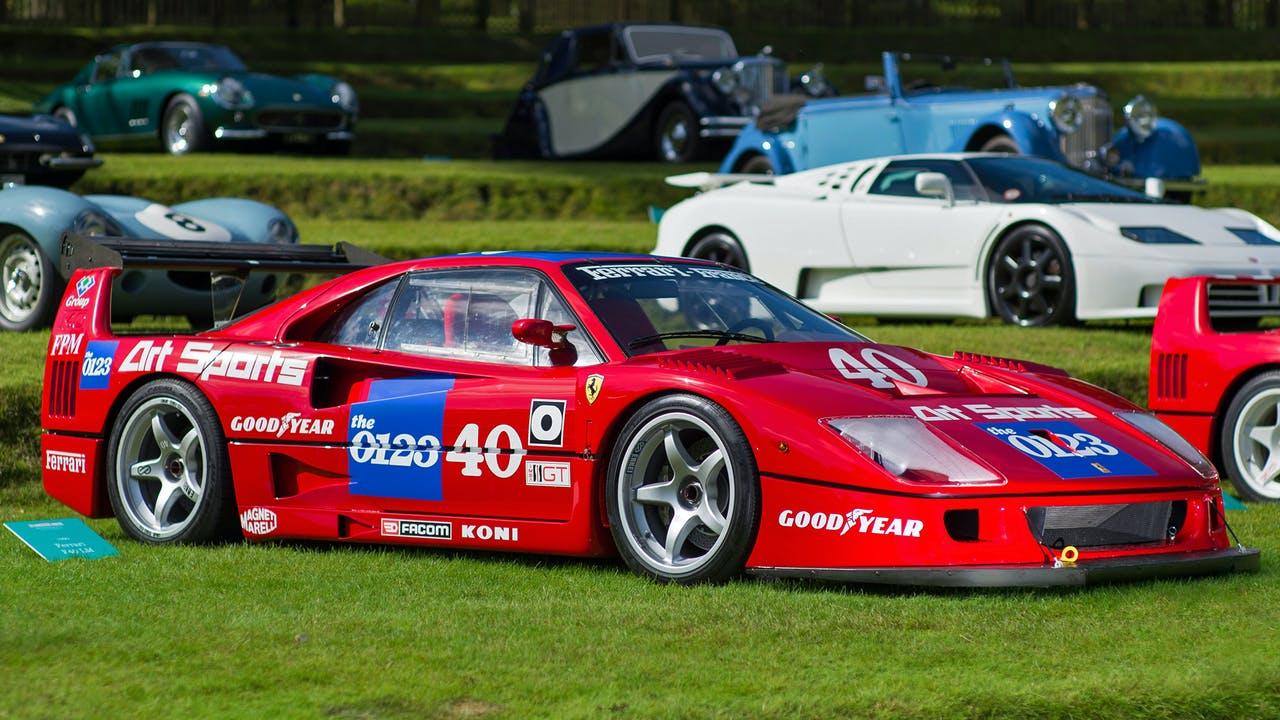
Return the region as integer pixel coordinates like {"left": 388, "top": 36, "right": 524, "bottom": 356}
{"left": 1027, "top": 501, "right": 1187, "bottom": 547}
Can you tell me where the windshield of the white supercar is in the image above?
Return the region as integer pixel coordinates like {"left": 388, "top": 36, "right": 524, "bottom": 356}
{"left": 968, "top": 158, "right": 1157, "bottom": 202}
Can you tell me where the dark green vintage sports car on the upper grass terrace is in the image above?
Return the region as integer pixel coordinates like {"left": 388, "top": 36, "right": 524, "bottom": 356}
{"left": 36, "top": 42, "right": 358, "bottom": 155}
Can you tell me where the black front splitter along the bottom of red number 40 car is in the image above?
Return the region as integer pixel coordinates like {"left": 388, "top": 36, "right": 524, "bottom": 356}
{"left": 748, "top": 546, "right": 1262, "bottom": 588}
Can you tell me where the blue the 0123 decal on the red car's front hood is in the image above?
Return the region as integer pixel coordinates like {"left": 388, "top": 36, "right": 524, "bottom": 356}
{"left": 978, "top": 420, "right": 1155, "bottom": 480}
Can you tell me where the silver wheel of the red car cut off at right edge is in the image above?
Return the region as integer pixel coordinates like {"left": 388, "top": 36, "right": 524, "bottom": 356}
{"left": 1220, "top": 370, "right": 1280, "bottom": 502}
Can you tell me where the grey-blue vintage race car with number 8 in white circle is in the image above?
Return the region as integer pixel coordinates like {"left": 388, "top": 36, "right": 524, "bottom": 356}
{"left": 0, "top": 186, "right": 301, "bottom": 331}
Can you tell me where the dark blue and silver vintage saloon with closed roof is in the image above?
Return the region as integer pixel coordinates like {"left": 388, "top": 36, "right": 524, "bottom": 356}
{"left": 494, "top": 24, "right": 831, "bottom": 163}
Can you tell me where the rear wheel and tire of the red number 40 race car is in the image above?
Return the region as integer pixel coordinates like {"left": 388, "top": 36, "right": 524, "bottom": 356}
{"left": 106, "top": 378, "right": 236, "bottom": 544}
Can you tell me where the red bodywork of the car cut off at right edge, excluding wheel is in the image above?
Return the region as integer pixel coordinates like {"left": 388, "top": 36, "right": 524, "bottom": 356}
{"left": 1148, "top": 277, "right": 1280, "bottom": 462}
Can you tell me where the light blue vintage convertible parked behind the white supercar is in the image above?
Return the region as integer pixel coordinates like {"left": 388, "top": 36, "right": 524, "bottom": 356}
{"left": 721, "top": 53, "right": 1201, "bottom": 192}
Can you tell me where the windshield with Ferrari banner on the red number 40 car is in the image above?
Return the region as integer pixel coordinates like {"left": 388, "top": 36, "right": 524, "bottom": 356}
{"left": 564, "top": 261, "right": 867, "bottom": 355}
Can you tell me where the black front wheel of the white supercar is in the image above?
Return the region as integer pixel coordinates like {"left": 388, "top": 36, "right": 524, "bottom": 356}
{"left": 987, "top": 224, "right": 1075, "bottom": 327}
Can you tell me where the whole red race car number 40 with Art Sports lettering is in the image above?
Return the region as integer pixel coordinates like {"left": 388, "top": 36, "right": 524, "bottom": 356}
{"left": 42, "top": 241, "right": 1258, "bottom": 585}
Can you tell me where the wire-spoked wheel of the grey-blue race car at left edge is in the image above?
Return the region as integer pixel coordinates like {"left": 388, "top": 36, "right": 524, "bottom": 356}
{"left": 0, "top": 228, "right": 63, "bottom": 332}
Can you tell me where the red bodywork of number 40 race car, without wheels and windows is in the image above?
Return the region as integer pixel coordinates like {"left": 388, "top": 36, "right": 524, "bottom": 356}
{"left": 42, "top": 254, "right": 1259, "bottom": 584}
